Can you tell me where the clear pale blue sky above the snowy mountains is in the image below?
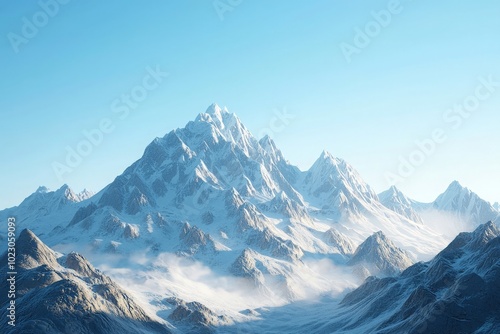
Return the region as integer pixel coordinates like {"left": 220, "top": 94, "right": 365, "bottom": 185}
{"left": 0, "top": 0, "right": 500, "bottom": 208}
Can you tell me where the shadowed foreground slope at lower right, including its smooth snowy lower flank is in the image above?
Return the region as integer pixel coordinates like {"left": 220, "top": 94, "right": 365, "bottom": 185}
{"left": 237, "top": 222, "right": 500, "bottom": 334}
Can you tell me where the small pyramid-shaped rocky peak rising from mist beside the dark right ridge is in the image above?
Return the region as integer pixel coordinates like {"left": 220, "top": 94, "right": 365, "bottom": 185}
{"left": 348, "top": 231, "right": 413, "bottom": 279}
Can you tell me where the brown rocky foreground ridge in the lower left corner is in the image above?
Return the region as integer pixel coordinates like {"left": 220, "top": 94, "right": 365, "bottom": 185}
{"left": 0, "top": 230, "right": 170, "bottom": 334}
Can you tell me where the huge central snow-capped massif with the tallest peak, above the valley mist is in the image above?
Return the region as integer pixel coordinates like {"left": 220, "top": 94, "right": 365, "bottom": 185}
{"left": 0, "top": 105, "right": 452, "bottom": 296}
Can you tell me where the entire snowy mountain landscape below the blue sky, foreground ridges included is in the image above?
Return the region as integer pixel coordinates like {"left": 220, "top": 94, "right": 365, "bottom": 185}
{"left": 0, "top": 104, "right": 499, "bottom": 333}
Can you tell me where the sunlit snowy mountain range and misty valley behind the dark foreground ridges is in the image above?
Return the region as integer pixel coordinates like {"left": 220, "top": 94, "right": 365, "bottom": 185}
{"left": 0, "top": 104, "right": 499, "bottom": 328}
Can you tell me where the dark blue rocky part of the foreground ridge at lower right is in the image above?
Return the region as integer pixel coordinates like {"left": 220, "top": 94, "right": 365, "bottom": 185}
{"left": 331, "top": 222, "right": 500, "bottom": 334}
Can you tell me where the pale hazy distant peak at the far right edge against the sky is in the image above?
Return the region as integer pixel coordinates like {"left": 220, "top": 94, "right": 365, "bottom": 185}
{"left": 432, "top": 181, "right": 498, "bottom": 224}
